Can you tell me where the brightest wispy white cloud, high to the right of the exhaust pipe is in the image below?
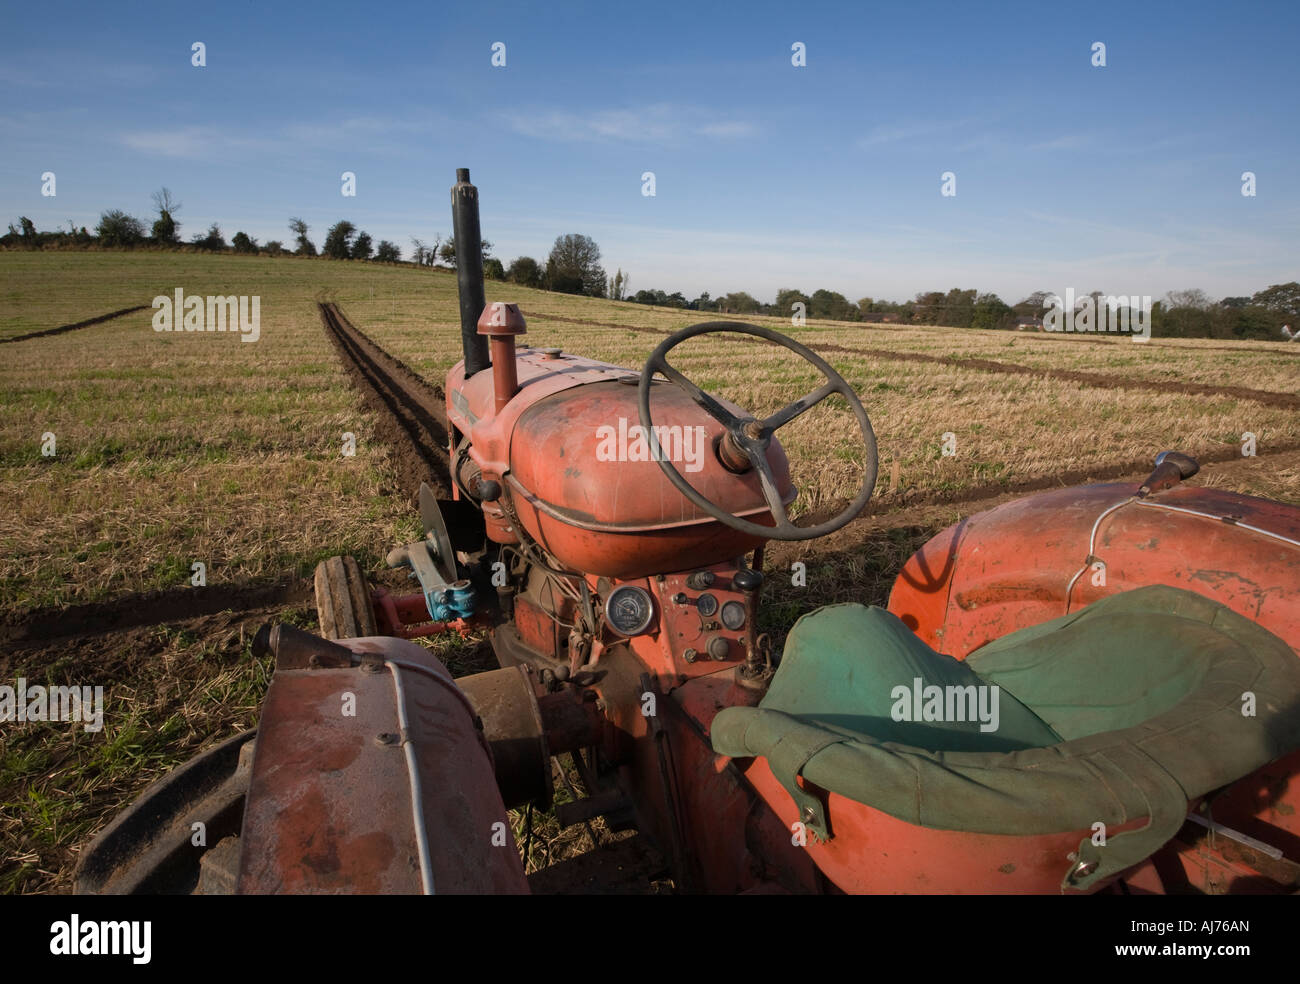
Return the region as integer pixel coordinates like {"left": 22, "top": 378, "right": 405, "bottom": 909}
{"left": 504, "top": 103, "right": 758, "bottom": 143}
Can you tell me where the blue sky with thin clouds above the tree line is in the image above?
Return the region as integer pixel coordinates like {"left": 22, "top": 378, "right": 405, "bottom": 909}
{"left": 0, "top": 0, "right": 1300, "bottom": 302}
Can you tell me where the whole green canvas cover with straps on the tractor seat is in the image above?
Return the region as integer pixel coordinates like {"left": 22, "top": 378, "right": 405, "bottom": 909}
{"left": 712, "top": 585, "right": 1300, "bottom": 888}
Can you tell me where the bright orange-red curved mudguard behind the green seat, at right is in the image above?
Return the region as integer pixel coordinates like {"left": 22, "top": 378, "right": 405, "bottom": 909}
{"left": 889, "top": 484, "right": 1300, "bottom": 659}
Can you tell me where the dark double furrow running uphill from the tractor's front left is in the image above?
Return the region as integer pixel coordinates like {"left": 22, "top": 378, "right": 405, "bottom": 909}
{"left": 317, "top": 303, "right": 451, "bottom": 499}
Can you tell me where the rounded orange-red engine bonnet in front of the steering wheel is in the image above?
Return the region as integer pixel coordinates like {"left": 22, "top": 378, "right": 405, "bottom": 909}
{"left": 447, "top": 330, "right": 796, "bottom": 578}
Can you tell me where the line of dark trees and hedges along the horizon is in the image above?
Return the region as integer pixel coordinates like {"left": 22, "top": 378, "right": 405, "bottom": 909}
{"left": 0, "top": 187, "right": 1300, "bottom": 339}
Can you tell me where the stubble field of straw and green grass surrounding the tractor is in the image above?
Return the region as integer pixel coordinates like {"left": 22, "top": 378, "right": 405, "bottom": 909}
{"left": 0, "top": 252, "right": 1300, "bottom": 892}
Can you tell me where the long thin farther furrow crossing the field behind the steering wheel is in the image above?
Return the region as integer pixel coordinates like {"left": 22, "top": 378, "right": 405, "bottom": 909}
{"left": 528, "top": 315, "right": 1300, "bottom": 409}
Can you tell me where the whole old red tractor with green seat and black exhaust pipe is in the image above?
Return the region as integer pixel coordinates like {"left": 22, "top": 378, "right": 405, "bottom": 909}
{"left": 78, "top": 173, "right": 1300, "bottom": 893}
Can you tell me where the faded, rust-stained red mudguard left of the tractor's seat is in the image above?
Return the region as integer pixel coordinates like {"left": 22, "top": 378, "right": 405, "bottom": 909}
{"left": 238, "top": 637, "right": 527, "bottom": 893}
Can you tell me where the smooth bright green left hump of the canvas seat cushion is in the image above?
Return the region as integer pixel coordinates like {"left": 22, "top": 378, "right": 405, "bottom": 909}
{"left": 762, "top": 604, "right": 1062, "bottom": 751}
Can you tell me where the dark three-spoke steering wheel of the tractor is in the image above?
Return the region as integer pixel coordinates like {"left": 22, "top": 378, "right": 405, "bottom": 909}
{"left": 638, "top": 321, "right": 879, "bottom": 539}
